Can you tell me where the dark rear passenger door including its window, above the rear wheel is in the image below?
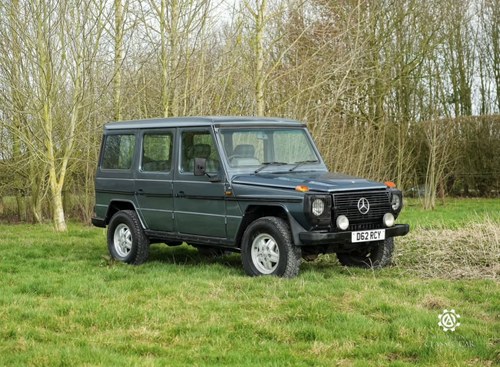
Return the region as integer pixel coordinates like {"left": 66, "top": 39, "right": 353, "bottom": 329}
{"left": 135, "top": 129, "right": 175, "bottom": 232}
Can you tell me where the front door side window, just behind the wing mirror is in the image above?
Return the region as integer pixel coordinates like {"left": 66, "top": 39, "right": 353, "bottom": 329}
{"left": 181, "top": 131, "right": 219, "bottom": 173}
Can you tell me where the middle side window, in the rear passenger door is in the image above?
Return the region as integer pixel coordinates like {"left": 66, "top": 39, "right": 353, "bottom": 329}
{"left": 142, "top": 134, "right": 172, "bottom": 172}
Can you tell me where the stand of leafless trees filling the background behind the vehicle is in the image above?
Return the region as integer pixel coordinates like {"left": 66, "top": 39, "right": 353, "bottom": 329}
{"left": 0, "top": 0, "right": 500, "bottom": 224}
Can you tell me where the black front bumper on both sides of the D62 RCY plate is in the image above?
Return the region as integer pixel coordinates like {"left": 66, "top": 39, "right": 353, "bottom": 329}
{"left": 299, "top": 224, "right": 410, "bottom": 246}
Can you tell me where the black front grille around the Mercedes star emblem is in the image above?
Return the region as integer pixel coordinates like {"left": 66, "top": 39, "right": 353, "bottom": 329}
{"left": 332, "top": 190, "right": 391, "bottom": 224}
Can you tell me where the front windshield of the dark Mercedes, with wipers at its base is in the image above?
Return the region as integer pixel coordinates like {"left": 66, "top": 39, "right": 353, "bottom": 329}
{"left": 220, "top": 128, "right": 320, "bottom": 172}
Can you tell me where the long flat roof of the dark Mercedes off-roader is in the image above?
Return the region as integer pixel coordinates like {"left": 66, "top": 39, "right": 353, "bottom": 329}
{"left": 104, "top": 116, "right": 304, "bottom": 130}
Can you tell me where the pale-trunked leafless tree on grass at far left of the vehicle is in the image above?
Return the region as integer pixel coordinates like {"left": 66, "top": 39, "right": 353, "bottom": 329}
{"left": 0, "top": 1, "right": 103, "bottom": 231}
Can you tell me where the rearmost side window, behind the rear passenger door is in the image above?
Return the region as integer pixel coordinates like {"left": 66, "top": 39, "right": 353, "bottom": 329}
{"left": 101, "top": 134, "right": 135, "bottom": 169}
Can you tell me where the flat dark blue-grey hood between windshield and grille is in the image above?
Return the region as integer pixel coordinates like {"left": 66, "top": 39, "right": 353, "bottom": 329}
{"left": 232, "top": 172, "right": 386, "bottom": 192}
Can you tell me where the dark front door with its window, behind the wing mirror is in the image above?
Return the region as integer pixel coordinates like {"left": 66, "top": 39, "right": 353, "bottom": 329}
{"left": 174, "top": 127, "right": 226, "bottom": 238}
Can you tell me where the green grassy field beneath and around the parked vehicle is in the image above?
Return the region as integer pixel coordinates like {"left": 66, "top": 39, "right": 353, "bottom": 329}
{"left": 0, "top": 200, "right": 500, "bottom": 367}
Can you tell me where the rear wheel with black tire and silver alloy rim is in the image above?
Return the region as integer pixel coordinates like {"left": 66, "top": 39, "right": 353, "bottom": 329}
{"left": 108, "top": 210, "right": 149, "bottom": 265}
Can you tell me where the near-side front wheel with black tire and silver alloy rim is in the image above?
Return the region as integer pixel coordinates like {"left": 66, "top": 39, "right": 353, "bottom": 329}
{"left": 241, "top": 217, "right": 302, "bottom": 278}
